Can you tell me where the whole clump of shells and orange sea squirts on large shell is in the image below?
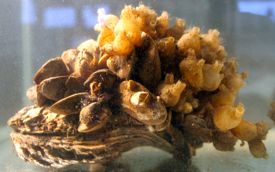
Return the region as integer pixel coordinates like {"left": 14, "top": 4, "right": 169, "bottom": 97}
{"left": 8, "top": 5, "right": 274, "bottom": 167}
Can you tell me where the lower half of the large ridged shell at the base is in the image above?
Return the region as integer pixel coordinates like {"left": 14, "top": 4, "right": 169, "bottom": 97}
{"left": 11, "top": 128, "right": 173, "bottom": 168}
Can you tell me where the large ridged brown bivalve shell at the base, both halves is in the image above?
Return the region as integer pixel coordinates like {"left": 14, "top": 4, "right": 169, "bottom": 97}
{"left": 8, "top": 105, "right": 179, "bottom": 168}
